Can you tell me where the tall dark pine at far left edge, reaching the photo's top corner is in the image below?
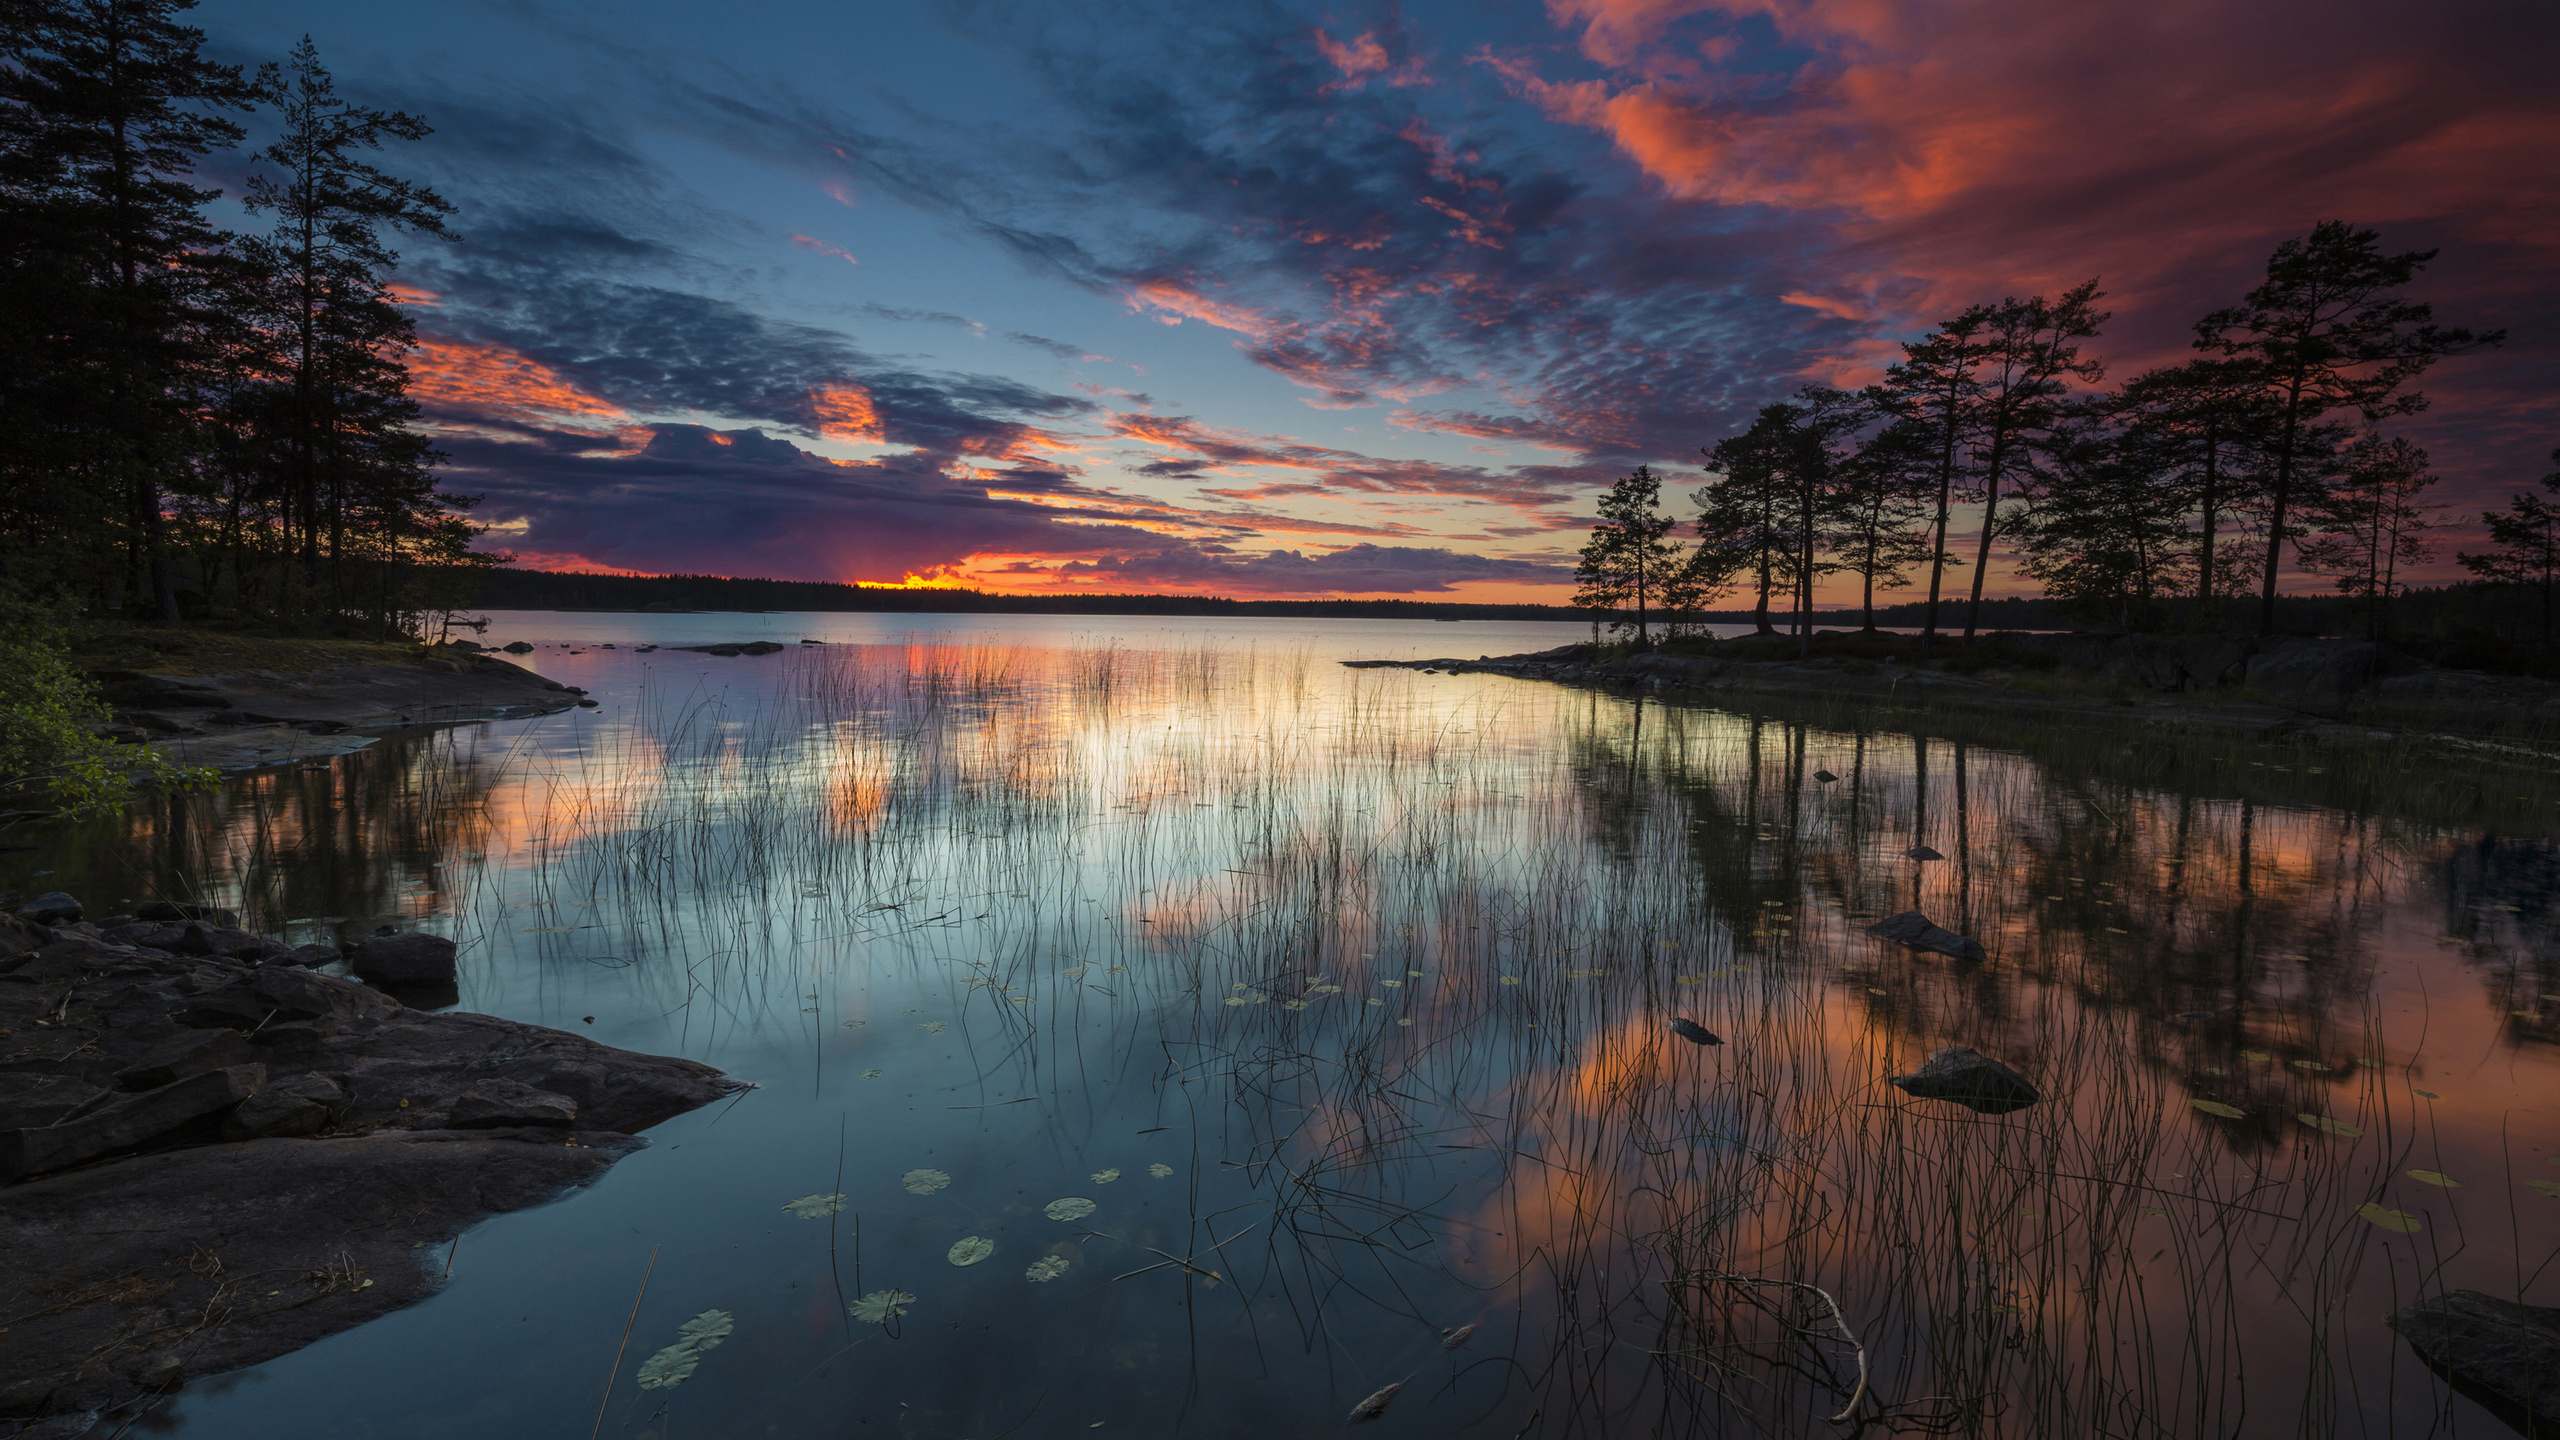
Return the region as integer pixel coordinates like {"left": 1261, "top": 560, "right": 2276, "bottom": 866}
{"left": 0, "top": 0, "right": 256, "bottom": 604}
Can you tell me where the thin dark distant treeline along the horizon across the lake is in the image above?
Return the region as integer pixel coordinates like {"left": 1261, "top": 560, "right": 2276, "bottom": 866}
{"left": 471, "top": 569, "right": 1587, "bottom": 620}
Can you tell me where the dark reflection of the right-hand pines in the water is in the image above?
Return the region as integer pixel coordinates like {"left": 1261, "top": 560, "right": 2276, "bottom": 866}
{"left": 1567, "top": 700, "right": 2508, "bottom": 1145}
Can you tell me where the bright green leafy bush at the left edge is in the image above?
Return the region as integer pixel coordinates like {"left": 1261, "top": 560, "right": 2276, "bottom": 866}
{"left": 0, "top": 594, "right": 212, "bottom": 817}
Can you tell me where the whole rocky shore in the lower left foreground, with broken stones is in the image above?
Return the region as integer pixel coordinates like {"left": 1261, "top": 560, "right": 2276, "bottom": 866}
{"left": 0, "top": 894, "right": 745, "bottom": 1437}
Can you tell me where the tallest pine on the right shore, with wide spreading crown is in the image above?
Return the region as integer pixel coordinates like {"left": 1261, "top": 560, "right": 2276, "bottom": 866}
{"left": 2196, "top": 220, "right": 2506, "bottom": 633}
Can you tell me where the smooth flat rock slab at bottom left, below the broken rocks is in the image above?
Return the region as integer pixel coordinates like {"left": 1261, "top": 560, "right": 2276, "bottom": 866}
{"left": 0, "top": 1130, "right": 640, "bottom": 1435}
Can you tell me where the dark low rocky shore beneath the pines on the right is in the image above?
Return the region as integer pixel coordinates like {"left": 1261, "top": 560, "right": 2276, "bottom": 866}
{"left": 1344, "top": 633, "right": 2560, "bottom": 758}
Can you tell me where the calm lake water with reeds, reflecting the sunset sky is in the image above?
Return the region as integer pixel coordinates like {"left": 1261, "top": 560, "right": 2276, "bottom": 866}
{"left": 0, "top": 612, "right": 2560, "bottom": 1440}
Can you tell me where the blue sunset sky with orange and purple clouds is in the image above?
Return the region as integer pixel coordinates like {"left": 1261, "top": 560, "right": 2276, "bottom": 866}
{"left": 192, "top": 0, "right": 2560, "bottom": 602}
